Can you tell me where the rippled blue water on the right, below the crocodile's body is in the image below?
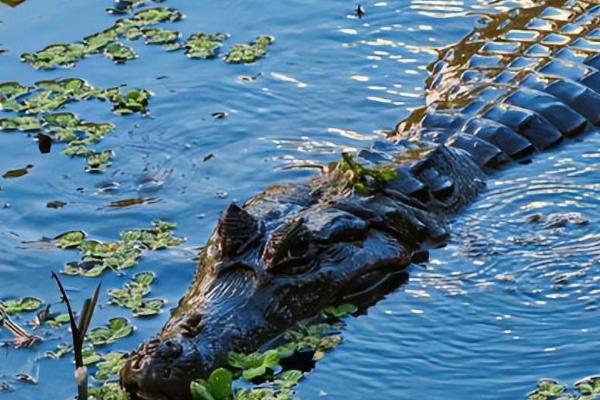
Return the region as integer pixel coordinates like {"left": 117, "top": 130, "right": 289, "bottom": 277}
{"left": 300, "top": 132, "right": 600, "bottom": 399}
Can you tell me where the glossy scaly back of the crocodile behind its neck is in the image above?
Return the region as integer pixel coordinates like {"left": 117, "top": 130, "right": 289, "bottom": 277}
{"left": 395, "top": 0, "right": 600, "bottom": 170}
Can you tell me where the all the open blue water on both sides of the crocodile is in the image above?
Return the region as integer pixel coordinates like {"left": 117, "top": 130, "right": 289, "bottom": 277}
{"left": 0, "top": 0, "right": 600, "bottom": 400}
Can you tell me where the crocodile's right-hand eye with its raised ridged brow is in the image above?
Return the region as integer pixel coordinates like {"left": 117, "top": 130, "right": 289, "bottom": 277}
{"left": 262, "top": 219, "right": 316, "bottom": 275}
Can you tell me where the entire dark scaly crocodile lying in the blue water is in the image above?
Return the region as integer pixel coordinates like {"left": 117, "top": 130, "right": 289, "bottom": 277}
{"left": 120, "top": 0, "right": 600, "bottom": 400}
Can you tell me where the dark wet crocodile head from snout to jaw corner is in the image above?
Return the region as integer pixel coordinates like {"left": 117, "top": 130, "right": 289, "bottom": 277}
{"left": 121, "top": 194, "right": 418, "bottom": 400}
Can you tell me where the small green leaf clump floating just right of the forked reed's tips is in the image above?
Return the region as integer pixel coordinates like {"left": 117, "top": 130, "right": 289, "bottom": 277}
{"left": 108, "top": 272, "right": 165, "bottom": 317}
